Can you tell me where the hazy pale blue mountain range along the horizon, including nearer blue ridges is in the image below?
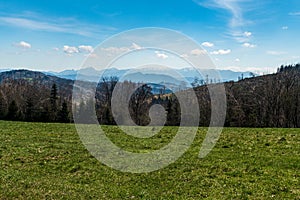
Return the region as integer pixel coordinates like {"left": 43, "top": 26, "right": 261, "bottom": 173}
{"left": 0, "top": 67, "right": 256, "bottom": 93}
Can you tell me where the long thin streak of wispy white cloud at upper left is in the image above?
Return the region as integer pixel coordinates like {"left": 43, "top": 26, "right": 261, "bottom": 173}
{"left": 0, "top": 14, "right": 115, "bottom": 37}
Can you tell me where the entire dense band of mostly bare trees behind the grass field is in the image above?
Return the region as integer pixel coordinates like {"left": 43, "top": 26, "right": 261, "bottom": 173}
{"left": 0, "top": 64, "right": 300, "bottom": 127}
